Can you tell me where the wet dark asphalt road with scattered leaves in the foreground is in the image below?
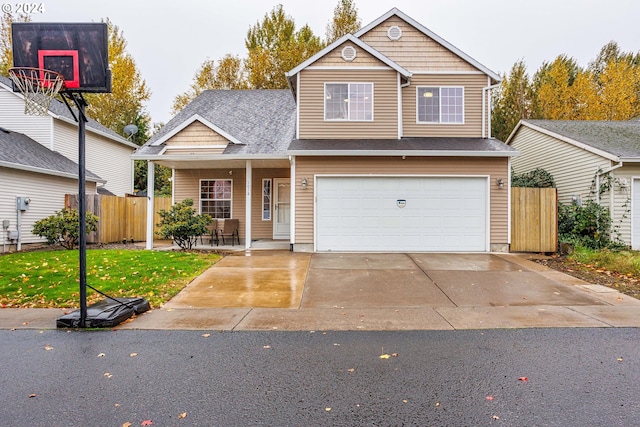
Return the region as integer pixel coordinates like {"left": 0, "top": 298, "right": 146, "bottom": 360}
{"left": 0, "top": 328, "right": 640, "bottom": 427}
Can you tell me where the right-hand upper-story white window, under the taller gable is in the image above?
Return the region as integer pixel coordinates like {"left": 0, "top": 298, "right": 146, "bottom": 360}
{"left": 417, "top": 87, "right": 464, "bottom": 124}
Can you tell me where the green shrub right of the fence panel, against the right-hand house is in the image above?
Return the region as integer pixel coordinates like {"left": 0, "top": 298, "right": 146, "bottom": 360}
{"left": 558, "top": 200, "right": 612, "bottom": 249}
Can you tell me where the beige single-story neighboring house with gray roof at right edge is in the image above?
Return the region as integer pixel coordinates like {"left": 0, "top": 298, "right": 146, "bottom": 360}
{"left": 507, "top": 119, "right": 640, "bottom": 249}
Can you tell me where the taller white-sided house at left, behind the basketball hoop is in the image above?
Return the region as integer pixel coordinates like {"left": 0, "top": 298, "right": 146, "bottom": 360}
{"left": 0, "top": 76, "right": 138, "bottom": 196}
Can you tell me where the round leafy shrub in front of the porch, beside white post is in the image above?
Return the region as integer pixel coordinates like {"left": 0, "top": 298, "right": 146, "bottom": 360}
{"left": 158, "top": 199, "right": 213, "bottom": 249}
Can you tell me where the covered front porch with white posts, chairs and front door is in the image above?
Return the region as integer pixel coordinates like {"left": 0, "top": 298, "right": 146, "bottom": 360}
{"left": 145, "top": 155, "right": 293, "bottom": 250}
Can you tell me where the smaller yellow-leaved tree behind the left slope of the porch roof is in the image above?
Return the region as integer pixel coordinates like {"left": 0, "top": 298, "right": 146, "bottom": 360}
{"left": 172, "top": 54, "right": 248, "bottom": 114}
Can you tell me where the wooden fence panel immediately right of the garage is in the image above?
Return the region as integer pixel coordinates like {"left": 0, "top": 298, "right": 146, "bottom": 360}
{"left": 511, "top": 187, "right": 558, "bottom": 252}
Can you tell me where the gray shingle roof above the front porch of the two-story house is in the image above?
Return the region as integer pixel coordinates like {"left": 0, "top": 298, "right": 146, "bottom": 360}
{"left": 136, "top": 89, "right": 296, "bottom": 156}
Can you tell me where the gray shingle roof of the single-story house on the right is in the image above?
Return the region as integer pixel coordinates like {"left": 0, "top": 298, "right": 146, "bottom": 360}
{"left": 525, "top": 120, "right": 640, "bottom": 158}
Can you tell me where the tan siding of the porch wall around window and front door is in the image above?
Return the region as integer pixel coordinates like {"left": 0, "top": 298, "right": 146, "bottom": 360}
{"left": 174, "top": 169, "right": 289, "bottom": 239}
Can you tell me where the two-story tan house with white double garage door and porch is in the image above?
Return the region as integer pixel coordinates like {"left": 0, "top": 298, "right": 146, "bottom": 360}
{"left": 138, "top": 9, "right": 517, "bottom": 252}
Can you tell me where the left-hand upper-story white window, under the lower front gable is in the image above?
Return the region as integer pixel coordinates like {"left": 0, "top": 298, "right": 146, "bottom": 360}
{"left": 324, "top": 83, "right": 373, "bottom": 121}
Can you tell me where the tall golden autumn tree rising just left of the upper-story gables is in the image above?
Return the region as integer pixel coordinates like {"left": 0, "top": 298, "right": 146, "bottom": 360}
{"left": 245, "top": 5, "right": 324, "bottom": 89}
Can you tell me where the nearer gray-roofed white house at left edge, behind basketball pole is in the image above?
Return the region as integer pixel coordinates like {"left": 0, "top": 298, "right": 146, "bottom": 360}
{"left": 0, "top": 128, "right": 105, "bottom": 252}
